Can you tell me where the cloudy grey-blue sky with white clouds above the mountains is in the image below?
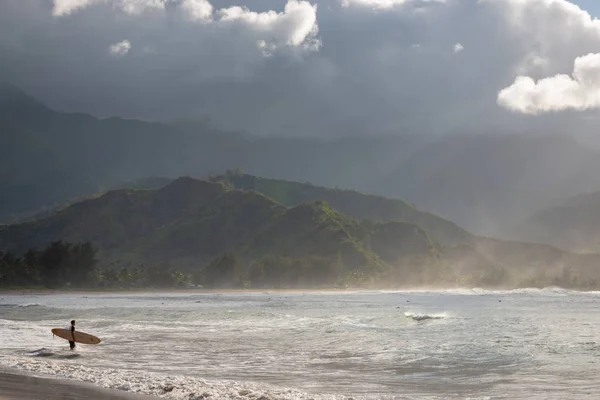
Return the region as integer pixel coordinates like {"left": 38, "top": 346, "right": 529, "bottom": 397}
{"left": 0, "top": 0, "right": 600, "bottom": 135}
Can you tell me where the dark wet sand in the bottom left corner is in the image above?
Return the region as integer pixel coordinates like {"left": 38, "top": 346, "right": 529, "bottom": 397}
{"left": 0, "top": 371, "right": 157, "bottom": 400}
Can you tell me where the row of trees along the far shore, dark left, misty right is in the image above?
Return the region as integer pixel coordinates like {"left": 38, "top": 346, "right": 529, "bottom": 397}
{"left": 0, "top": 241, "right": 600, "bottom": 289}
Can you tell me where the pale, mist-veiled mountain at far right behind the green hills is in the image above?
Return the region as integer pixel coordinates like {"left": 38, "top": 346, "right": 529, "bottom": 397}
{"left": 370, "top": 133, "right": 600, "bottom": 237}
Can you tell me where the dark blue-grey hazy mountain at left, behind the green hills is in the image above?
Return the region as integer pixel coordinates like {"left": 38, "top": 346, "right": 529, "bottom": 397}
{"left": 0, "top": 84, "right": 432, "bottom": 223}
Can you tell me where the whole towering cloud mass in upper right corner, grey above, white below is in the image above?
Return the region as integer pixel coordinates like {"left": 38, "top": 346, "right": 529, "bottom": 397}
{"left": 492, "top": 0, "right": 600, "bottom": 115}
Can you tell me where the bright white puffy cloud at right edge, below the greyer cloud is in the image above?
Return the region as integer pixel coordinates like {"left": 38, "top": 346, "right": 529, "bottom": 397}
{"left": 498, "top": 54, "right": 600, "bottom": 114}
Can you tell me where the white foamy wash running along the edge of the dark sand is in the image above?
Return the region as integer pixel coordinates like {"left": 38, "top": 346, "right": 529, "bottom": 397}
{"left": 0, "top": 358, "right": 348, "bottom": 400}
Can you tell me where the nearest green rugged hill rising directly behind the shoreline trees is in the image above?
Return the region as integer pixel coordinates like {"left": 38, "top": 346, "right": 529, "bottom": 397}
{"left": 0, "top": 178, "right": 437, "bottom": 283}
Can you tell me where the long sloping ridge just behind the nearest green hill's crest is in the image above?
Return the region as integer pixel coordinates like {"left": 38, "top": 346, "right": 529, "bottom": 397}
{"left": 212, "top": 171, "right": 473, "bottom": 246}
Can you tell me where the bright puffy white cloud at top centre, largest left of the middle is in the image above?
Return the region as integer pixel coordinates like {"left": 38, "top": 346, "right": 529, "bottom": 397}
{"left": 217, "top": 0, "right": 318, "bottom": 49}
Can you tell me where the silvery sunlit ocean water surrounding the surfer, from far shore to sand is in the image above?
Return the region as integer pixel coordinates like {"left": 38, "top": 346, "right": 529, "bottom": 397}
{"left": 0, "top": 288, "right": 600, "bottom": 400}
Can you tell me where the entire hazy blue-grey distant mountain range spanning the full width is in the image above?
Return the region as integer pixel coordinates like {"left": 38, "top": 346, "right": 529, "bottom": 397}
{"left": 0, "top": 84, "right": 600, "bottom": 245}
